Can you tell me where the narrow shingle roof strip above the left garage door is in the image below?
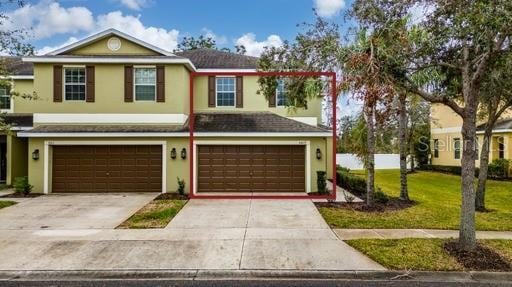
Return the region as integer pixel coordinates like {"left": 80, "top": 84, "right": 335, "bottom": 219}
{"left": 30, "top": 125, "right": 188, "bottom": 133}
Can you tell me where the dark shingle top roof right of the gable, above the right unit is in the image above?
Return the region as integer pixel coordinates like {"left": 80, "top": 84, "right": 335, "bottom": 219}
{"left": 175, "top": 49, "right": 258, "bottom": 69}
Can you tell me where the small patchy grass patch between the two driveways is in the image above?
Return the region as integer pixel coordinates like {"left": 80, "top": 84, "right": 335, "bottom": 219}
{"left": 118, "top": 198, "right": 187, "bottom": 229}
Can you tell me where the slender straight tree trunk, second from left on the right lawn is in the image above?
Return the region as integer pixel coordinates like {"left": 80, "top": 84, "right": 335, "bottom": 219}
{"left": 398, "top": 93, "right": 409, "bottom": 201}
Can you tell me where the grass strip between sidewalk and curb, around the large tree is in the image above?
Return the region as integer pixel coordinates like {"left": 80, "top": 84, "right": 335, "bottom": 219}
{"left": 347, "top": 238, "right": 512, "bottom": 271}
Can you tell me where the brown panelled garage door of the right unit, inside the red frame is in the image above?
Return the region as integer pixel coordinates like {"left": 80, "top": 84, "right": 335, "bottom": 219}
{"left": 198, "top": 145, "right": 305, "bottom": 192}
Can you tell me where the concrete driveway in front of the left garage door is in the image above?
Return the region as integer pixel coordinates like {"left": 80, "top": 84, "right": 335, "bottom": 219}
{"left": 0, "top": 193, "right": 158, "bottom": 230}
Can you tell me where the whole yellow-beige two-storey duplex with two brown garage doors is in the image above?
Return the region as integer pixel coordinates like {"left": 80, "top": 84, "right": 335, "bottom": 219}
{"left": 0, "top": 29, "right": 332, "bottom": 194}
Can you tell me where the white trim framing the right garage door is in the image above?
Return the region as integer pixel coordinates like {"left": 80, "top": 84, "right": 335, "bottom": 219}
{"left": 192, "top": 140, "right": 311, "bottom": 195}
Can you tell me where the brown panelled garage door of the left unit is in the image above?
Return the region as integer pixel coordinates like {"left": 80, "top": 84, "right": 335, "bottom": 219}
{"left": 52, "top": 145, "right": 162, "bottom": 192}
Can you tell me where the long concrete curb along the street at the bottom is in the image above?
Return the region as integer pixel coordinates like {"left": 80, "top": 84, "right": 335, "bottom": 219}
{"left": 0, "top": 269, "right": 512, "bottom": 282}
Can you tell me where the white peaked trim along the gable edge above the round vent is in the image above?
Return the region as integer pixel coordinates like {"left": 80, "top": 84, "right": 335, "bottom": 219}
{"left": 46, "top": 28, "right": 174, "bottom": 56}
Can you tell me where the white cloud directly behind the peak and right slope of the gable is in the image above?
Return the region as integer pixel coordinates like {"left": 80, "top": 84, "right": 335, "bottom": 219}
{"left": 96, "top": 11, "right": 179, "bottom": 51}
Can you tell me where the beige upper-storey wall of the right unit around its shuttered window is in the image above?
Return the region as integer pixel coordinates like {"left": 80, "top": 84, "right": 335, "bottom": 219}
{"left": 194, "top": 76, "right": 322, "bottom": 123}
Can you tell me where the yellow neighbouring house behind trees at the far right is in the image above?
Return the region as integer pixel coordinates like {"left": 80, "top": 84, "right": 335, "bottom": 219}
{"left": 430, "top": 104, "right": 512, "bottom": 171}
